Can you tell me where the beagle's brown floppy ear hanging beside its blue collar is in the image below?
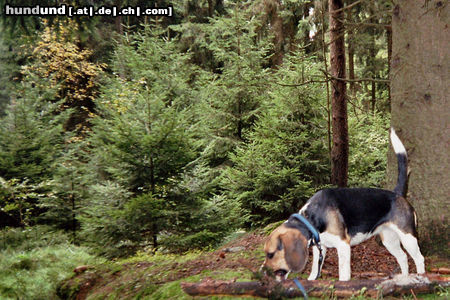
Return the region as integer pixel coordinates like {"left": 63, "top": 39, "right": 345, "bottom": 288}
{"left": 280, "top": 230, "right": 308, "bottom": 272}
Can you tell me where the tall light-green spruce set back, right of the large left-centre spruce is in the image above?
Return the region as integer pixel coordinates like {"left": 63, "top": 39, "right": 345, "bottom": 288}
{"left": 196, "top": 4, "right": 270, "bottom": 166}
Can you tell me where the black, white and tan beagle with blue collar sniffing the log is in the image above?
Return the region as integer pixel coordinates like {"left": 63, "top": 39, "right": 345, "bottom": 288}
{"left": 262, "top": 129, "right": 425, "bottom": 281}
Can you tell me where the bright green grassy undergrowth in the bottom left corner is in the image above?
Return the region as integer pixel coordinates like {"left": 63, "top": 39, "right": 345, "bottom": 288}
{"left": 0, "top": 227, "right": 103, "bottom": 300}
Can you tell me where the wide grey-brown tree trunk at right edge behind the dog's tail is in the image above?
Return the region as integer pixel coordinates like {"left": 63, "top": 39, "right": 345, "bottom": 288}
{"left": 388, "top": 0, "right": 450, "bottom": 255}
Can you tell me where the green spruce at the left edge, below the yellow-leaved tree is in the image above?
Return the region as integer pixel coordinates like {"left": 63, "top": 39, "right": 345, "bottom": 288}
{"left": 0, "top": 76, "right": 66, "bottom": 225}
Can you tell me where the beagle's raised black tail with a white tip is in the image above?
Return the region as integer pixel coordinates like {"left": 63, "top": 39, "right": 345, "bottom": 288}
{"left": 391, "top": 128, "right": 408, "bottom": 197}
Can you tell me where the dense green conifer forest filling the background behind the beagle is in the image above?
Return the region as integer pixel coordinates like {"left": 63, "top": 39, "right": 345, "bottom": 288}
{"left": 0, "top": 0, "right": 449, "bottom": 298}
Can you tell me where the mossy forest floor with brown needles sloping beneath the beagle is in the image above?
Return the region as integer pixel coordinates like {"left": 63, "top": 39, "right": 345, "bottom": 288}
{"left": 58, "top": 230, "right": 450, "bottom": 299}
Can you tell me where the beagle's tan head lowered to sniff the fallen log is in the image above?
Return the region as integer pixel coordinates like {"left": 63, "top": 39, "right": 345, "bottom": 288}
{"left": 262, "top": 224, "right": 308, "bottom": 281}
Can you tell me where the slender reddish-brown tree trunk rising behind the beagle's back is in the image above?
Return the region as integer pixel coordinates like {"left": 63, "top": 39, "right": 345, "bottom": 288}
{"left": 328, "top": 0, "right": 348, "bottom": 187}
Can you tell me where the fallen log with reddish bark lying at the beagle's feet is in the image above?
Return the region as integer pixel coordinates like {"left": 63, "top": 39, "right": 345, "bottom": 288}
{"left": 181, "top": 274, "right": 450, "bottom": 298}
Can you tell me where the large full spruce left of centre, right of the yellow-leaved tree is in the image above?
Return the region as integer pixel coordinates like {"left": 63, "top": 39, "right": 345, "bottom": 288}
{"left": 81, "top": 26, "right": 195, "bottom": 254}
